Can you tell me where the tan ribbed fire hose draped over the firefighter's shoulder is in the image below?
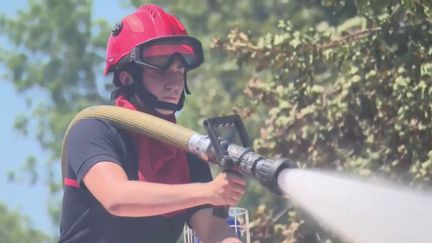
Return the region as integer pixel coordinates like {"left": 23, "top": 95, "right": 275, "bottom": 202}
{"left": 62, "top": 106, "right": 196, "bottom": 181}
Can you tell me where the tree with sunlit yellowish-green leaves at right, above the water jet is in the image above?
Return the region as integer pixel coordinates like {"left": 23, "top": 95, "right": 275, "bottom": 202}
{"left": 217, "top": 0, "right": 432, "bottom": 242}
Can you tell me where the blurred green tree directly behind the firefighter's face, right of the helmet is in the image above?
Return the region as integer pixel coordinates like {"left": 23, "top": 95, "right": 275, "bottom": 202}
{"left": 125, "top": 0, "right": 338, "bottom": 218}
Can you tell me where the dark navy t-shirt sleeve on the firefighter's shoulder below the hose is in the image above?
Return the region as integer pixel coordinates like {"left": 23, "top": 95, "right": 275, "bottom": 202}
{"left": 65, "top": 119, "right": 121, "bottom": 184}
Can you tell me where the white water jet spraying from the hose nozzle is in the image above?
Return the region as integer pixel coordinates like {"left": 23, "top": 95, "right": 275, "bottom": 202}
{"left": 278, "top": 169, "right": 432, "bottom": 243}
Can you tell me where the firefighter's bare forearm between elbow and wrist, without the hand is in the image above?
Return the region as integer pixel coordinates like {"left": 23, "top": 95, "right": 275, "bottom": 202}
{"left": 106, "top": 181, "right": 208, "bottom": 217}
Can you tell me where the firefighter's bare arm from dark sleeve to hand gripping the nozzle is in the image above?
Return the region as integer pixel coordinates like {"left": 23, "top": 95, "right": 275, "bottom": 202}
{"left": 83, "top": 162, "right": 245, "bottom": 217}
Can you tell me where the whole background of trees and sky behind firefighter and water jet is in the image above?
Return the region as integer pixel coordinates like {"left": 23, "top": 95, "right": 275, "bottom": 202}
{"left": 0, "top": 0, "right": 432, "bottom": 243}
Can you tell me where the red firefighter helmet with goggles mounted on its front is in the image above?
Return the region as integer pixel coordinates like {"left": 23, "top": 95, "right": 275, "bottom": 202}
{"left": 104, "top": 4, "right": 204, "bottom": 75}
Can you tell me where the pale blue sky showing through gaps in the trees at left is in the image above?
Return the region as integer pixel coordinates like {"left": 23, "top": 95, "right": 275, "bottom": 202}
{"left": 0, "top": 0, "right": 133, "bottom": 235}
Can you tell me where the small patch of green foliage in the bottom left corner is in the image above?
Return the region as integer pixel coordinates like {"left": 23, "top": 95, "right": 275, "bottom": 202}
{"left": 0, "top": 203, "right": 50, "bottom": 243}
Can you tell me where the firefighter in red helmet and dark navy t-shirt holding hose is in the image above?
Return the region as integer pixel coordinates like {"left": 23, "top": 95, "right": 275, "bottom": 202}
{"left": 60, "top": 4, "right": 246, "bottom": 243}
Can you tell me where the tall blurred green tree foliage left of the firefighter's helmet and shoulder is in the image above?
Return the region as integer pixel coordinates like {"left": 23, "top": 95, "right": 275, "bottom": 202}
{"left": 0, "top": 0, "right": 109, "bottom": 226}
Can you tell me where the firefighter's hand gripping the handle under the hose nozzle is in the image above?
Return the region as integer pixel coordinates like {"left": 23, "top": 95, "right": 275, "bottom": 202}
{"left": 207, "top": 172, "right": 246, "bottom": 206}
